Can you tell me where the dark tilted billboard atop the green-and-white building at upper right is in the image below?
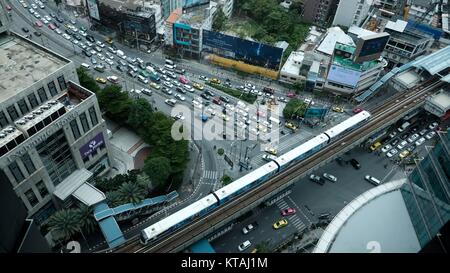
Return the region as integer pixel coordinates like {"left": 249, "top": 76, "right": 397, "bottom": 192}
{"left": 353, "top": 32, "right": 390, "bottom": 63}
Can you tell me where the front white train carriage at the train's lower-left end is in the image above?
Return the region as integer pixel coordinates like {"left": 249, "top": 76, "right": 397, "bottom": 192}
{"left": 140, "top": 194, "right": 218, "bottom": 244}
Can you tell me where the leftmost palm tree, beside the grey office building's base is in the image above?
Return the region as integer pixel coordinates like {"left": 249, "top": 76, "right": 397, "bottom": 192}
{"left": 48, "top": 209, "right": 80, "bottom": 240}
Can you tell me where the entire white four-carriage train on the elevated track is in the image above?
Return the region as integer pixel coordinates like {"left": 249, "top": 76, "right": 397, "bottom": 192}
{"left": 140, "top": 111, "right": 371, "bottom": 244}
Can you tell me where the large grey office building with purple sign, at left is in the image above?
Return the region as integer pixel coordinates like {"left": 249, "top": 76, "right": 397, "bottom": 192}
{"left": 0, "top": 27, "right": 111, "bottom": 225}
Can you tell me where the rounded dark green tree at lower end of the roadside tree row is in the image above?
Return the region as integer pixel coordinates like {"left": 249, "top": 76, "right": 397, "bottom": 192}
{"left": 144, "top": 156, "right": 171, "bottom": 188}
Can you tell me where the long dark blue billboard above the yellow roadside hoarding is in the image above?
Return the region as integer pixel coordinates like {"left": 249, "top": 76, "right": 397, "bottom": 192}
{"left": 202, "top": 30, "right": 283, "bottom": 70}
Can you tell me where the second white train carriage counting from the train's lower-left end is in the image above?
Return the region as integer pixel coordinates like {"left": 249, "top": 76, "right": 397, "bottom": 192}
{"left": 214, "top": 161, "right": 278, "bottom": 204}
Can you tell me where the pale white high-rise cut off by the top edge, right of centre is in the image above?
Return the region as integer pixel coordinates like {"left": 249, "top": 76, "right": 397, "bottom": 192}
{"left": 333, "top": 0, "right": 372, "bottom": 27}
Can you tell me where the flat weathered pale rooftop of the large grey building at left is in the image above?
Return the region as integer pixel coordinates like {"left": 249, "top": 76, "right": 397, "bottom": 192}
{"left": 0, "top": 35, "right": 70, "bottom": 102}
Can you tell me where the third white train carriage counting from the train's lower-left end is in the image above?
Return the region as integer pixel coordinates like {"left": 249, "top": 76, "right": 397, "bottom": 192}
{"left": 276, "top": 134, "right": 328, "bottom": 170}
